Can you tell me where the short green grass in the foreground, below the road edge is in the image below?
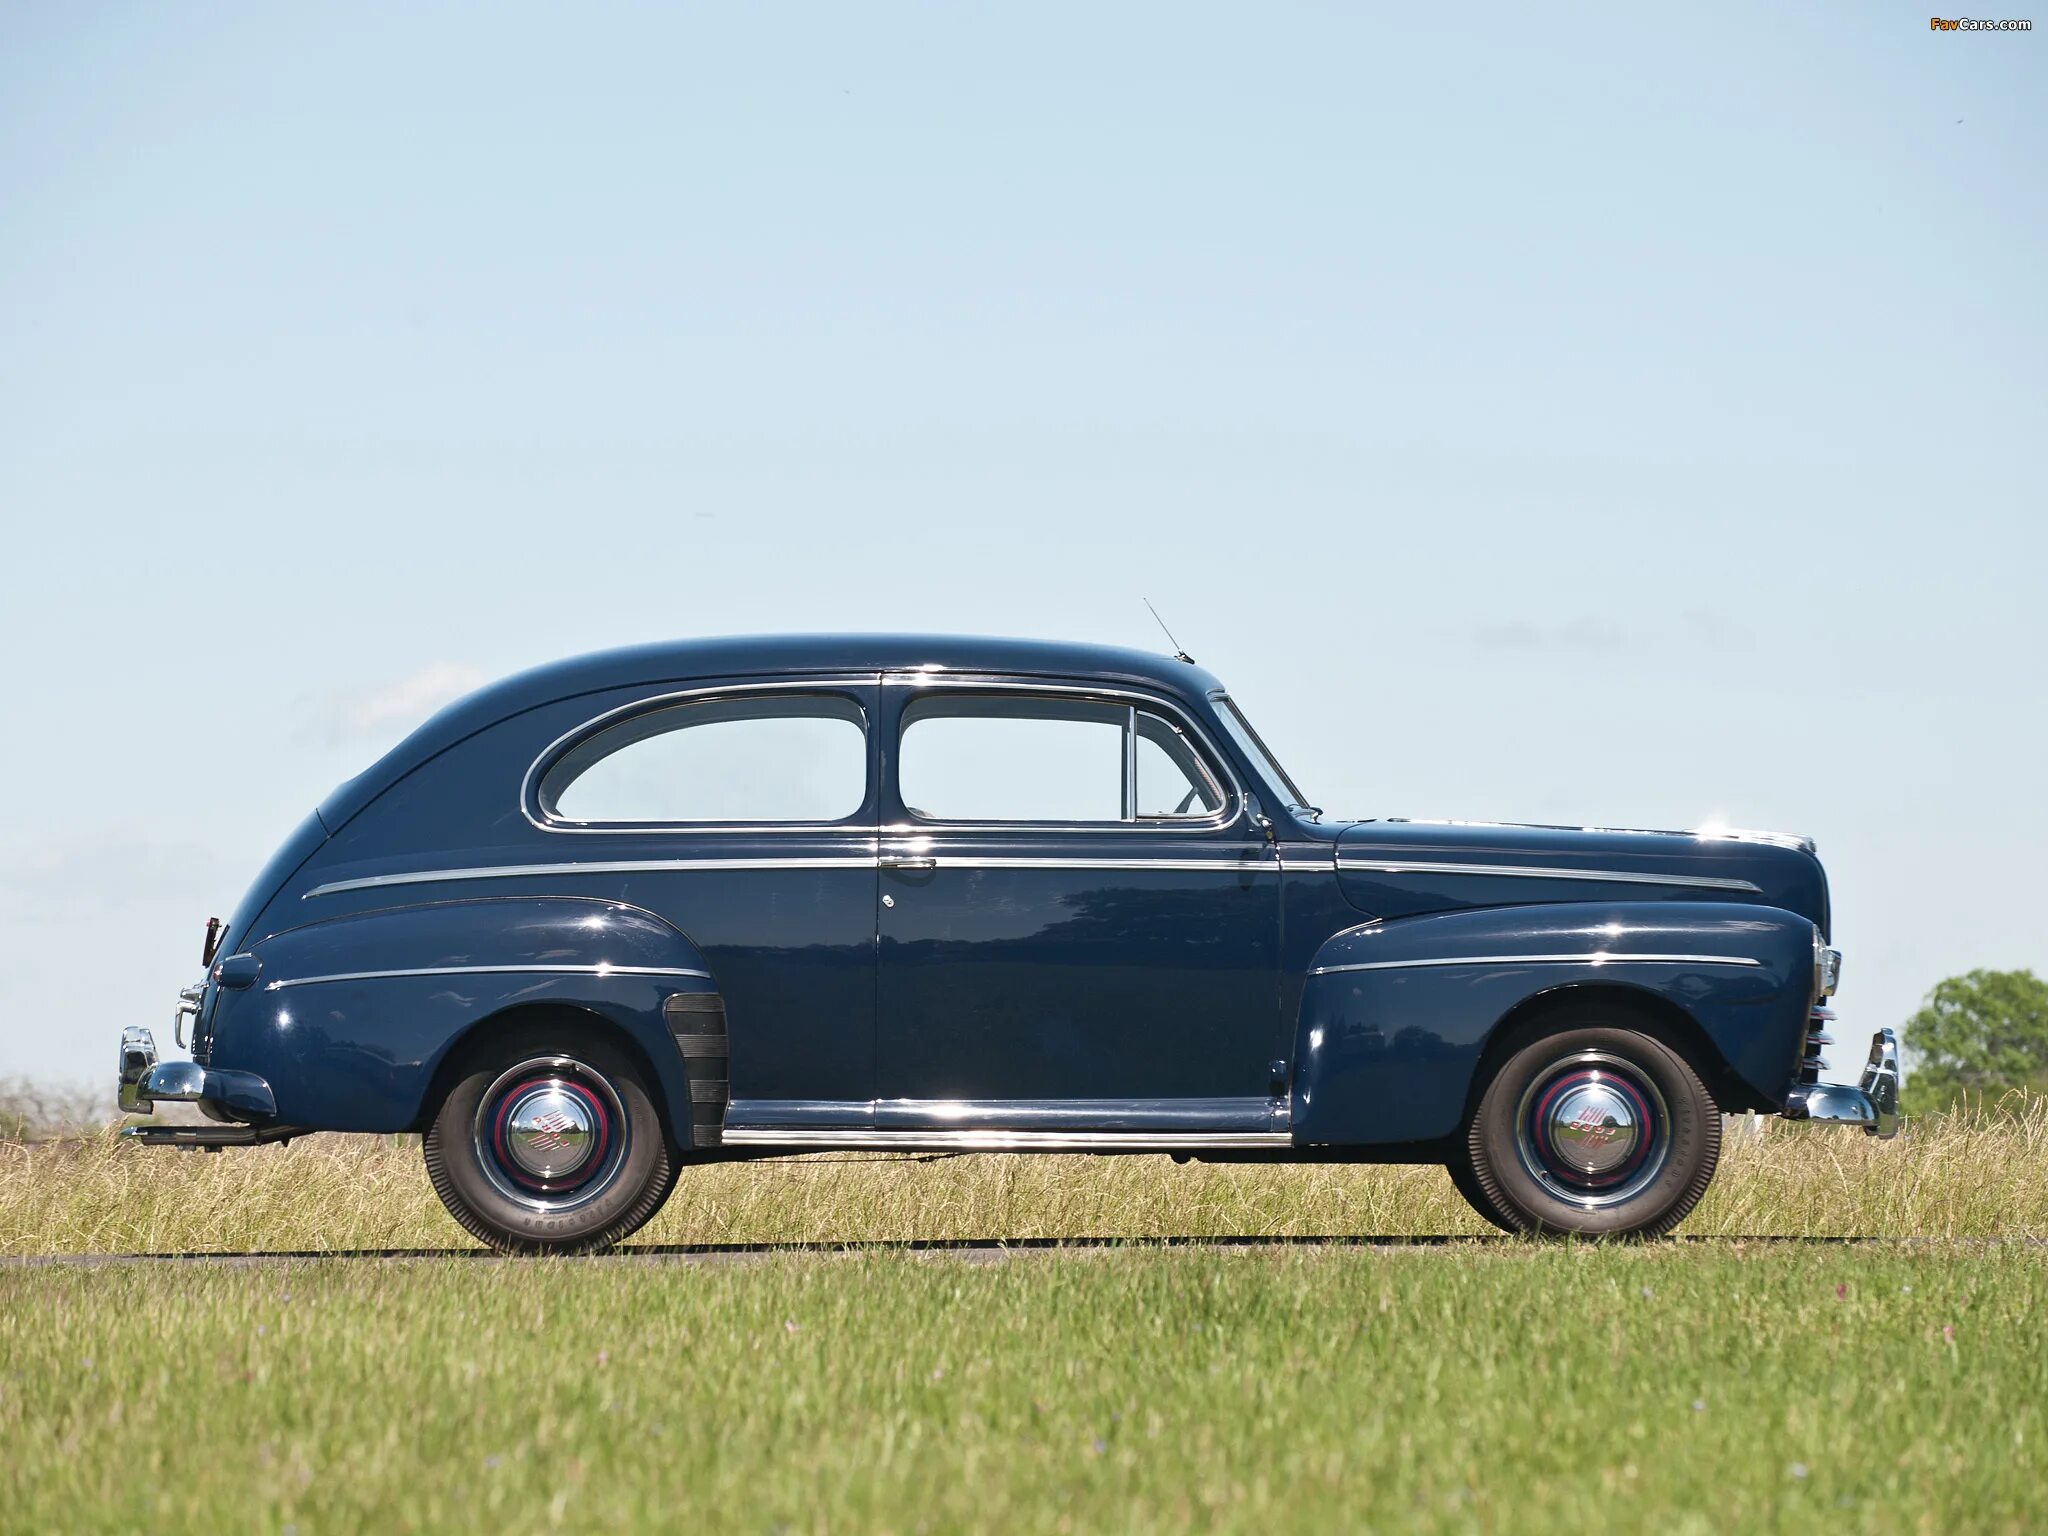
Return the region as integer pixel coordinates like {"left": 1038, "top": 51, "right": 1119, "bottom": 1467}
{"left": 0, "top": 1243, "right": 2048, "bottom": 1536}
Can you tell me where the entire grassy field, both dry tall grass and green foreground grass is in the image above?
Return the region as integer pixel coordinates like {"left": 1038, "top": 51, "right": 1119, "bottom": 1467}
{"left": 0, "top": 1100, "right": 2048, "bottom": 1536}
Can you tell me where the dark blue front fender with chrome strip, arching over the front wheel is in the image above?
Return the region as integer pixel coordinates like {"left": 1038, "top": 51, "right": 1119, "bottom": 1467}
{"left": 1290, "top": 901, "right": 1815, "bottom": 1145}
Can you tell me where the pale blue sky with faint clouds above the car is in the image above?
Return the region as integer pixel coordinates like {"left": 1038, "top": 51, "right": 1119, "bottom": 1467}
{"left": 0, "top": 4, "right": 2048, "bottom": 1079}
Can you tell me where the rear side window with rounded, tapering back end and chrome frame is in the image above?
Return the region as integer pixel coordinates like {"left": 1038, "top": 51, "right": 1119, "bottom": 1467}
{"left": 541, "top": 694, "right": 868, "bottom": 825}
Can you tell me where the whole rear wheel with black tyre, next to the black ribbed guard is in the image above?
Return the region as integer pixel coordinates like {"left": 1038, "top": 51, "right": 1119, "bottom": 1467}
{"left": 424, "top": 1026, "right": 676, "bottom": 1253}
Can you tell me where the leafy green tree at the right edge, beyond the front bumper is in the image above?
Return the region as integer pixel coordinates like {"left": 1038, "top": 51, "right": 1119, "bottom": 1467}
{"left": 1905, "top": 971, "right": 2048, "bottom": 1110}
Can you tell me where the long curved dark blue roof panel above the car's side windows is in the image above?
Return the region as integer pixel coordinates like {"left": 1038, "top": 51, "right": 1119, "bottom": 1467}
{"left": 319, "top": 635, "right": 1219, "bottom": 831}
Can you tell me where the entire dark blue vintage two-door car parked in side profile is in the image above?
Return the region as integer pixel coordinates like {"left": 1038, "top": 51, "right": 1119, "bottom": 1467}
{"left": 121, "top": 635, "right": 1898, "bottom": 1251}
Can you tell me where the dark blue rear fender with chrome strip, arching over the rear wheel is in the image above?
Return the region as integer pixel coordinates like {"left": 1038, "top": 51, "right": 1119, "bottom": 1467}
{"left": 209, "top": 897, "right": 715, "bottom": 1130}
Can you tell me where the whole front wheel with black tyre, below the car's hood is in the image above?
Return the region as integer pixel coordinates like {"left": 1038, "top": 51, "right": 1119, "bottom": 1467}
{"left": 1460, "top": 1014, "right": 1720, "bottom": 1237}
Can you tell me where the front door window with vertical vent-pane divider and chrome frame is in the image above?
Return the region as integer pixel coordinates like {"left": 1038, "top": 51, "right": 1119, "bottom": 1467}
{"left": 897, "top": 694, "right": 1225, "bottom": 821}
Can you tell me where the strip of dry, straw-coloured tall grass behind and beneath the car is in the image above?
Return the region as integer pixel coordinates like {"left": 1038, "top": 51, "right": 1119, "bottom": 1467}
{"left": 0, "top": 1096, "right": 2048, "bottom": 1255}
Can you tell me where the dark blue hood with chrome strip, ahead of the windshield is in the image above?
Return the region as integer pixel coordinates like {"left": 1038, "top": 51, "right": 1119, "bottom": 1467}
{"left": 1337, "top": 821, "right": 1829, "bottom": 934}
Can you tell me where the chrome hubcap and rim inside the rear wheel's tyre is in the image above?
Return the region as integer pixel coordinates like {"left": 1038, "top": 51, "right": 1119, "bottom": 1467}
{"left": 475, "top": 1057, "right": 627, "bottom": 1212}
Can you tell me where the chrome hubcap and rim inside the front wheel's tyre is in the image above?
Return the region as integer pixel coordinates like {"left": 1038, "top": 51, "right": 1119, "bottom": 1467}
{"left": 1516, "top": 1051, "right": 1671, "bottom": 1210}
